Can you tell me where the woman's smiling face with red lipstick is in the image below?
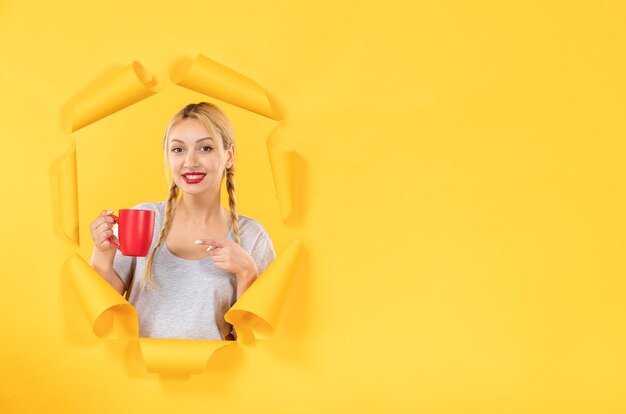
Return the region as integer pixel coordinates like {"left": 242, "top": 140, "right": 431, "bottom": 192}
{"left": 168, "top": 118, "right": 233, "bottom": 196}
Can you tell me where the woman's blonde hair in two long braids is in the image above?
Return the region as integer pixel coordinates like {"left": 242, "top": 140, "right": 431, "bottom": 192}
{"left": 142, "top": 102, "right": 239, "bottom": 289}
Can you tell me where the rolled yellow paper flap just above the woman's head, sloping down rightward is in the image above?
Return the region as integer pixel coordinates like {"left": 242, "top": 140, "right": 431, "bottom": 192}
{"left": 170, "top": 55, "right": 279, "bottom": 120}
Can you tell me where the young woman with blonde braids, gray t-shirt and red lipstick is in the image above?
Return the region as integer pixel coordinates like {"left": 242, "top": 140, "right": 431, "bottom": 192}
{"left": 90, "top": 102, "right": 276, "bottom": 340}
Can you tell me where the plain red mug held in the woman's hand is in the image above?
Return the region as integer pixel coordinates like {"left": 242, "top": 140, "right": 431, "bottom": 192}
{"left": 109, "top": 209, "right": 154, "bottom": 256}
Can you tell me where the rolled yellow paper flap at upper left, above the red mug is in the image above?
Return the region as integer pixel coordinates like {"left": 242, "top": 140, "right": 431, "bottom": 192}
{"left": 61, "top": 61, "right": 158, "bottom": 132}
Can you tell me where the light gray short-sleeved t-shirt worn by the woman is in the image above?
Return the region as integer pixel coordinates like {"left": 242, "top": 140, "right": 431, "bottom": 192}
{"left": 113, "top": 201, "right": 276, "bottom": 340}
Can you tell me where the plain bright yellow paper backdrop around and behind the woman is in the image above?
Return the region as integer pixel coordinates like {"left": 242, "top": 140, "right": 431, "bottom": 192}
{"left": 0, "top": 1, "right": 626, "bottom": 413}
